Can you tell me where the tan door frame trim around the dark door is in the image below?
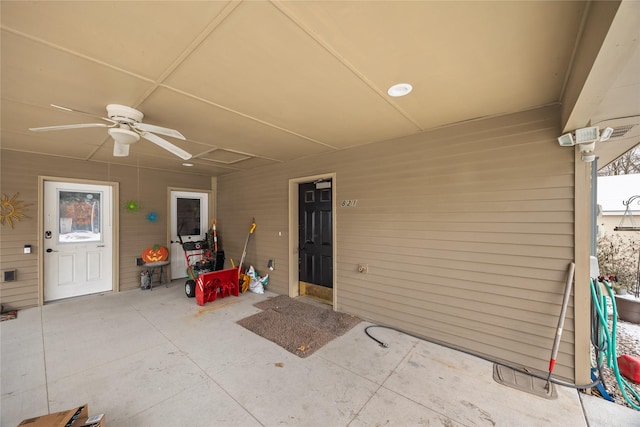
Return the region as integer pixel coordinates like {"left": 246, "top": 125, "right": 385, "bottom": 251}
{"left": 289, "top": 172, "right": 338, "bottom": 311}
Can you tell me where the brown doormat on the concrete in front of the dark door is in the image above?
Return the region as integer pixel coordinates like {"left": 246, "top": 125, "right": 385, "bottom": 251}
{"left": 237, "top": 295, "right": 360, "bottom": 358}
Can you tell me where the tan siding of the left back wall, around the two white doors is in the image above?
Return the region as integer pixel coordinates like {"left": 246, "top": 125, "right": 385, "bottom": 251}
{"left": 0, "top": 150, "right": 211, "bottom": 308}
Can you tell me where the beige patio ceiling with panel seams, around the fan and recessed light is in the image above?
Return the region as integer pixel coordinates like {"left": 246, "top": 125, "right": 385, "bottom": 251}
{"left": 0, "top": 0, "right": 640, "bottom": 176}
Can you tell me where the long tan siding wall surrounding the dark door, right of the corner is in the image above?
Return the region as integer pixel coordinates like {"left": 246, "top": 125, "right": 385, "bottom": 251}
{"left": 218, "top": 107, "right": 574, "bottom": 379}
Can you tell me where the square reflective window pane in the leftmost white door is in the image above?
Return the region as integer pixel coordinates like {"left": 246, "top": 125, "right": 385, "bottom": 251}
{"left": 58, "top": 191, "right": 102, "bottom": 243}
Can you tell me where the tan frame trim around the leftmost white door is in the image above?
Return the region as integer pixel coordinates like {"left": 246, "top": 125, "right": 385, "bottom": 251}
{"left": 37, "top": 175, "right": 120, "bottom": 306}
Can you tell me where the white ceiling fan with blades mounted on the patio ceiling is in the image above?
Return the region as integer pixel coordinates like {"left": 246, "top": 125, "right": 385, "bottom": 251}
{"left": 29, "top": 104, "right": 191, "bottom": 160}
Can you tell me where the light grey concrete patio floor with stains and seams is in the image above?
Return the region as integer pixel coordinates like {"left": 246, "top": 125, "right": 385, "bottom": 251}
{"left": 0, "top": 281, "right": 640, "bottom": 427}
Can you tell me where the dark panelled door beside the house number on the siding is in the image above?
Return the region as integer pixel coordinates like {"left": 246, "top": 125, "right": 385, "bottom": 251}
{"left": 298, "top": 180, "right": 333, "bottom": 288}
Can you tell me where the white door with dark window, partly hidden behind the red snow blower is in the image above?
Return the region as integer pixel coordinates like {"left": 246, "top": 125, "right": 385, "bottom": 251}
{"left": 171, "top": 191, "right": 209, "bottom": 280}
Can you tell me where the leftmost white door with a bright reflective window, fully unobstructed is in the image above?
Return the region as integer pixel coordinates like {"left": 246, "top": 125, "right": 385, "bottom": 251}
{"left": 43, "top": 181, "right": 113, "bottom": 301}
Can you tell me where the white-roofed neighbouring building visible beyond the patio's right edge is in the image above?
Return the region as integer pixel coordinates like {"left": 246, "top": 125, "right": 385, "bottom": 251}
{"left": 597, "top": 174, "right": 640, "bottom": 238}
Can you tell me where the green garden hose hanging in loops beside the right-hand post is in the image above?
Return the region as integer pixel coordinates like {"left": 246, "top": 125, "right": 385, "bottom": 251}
{"left": 590, "top": 279, "right": 640, "bottom": 411}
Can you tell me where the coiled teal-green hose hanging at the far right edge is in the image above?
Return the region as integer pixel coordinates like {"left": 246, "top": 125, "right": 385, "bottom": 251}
{"left": 590, "top": 279, "right": 640, "bottom": 411}
